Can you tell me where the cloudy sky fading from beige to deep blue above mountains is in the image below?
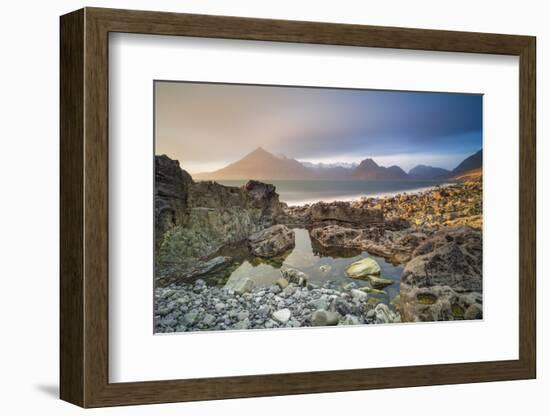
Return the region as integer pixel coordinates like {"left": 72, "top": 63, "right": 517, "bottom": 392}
{"left": 155, "top": 81, "right": 482, "bottom": 173}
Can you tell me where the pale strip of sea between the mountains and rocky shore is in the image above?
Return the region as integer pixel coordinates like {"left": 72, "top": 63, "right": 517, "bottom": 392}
{"left": 216, "top": 180, "right": 455, "bottom": 205}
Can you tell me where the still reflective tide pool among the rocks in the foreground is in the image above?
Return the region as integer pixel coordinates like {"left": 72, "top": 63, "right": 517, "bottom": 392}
{"left": 201, "top": 229, "right": 403, "bottom": 303}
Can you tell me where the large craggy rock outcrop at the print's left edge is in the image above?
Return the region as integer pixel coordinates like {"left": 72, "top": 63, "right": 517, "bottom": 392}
{"left": 155, "top": 155, "right": 282, "bottom": 282}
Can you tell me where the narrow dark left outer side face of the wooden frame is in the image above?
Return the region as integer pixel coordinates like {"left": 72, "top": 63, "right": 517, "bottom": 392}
{"left": 59, "top": 10, "right": 85, "bottom": 406}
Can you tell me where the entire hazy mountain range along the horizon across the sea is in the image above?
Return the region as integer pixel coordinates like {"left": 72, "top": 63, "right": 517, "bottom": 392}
{"left": 193, "top": 147, "right": 482, "bottom": 181}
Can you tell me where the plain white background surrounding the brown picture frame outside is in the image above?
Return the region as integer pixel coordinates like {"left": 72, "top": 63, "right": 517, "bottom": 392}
{"left": 0, "top": 0, "right": 550, "bottom": 416}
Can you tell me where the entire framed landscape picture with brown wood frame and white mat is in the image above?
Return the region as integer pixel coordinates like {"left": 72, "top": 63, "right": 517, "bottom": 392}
{"left": 60, "top": 8, "right": 536, "bottom": 407}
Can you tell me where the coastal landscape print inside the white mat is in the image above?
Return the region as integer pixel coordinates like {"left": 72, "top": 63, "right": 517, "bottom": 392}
{"left": 154, "top": 81, "right": 483, "bottom": 333}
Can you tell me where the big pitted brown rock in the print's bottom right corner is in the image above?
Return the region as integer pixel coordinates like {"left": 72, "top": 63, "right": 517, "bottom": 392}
{"left": 400, "top": 227, "right": 482, "bottom": 322}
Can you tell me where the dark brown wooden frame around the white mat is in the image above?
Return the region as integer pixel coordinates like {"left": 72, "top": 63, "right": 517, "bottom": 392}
{"left": 60, "top": 8, "right": 536, "bottom": 407}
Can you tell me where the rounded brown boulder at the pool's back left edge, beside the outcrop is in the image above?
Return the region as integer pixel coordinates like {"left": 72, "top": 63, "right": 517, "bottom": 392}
{"left": 248, "top": 224, "right": 295, "bottom": 258}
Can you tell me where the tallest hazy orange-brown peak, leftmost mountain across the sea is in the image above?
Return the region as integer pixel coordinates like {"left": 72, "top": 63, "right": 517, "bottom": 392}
{"left": 193, "top": 147, "right": 315, "bottom": 180}
